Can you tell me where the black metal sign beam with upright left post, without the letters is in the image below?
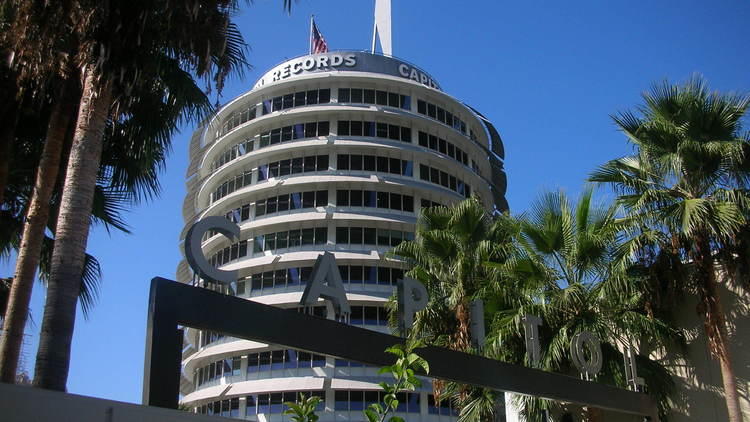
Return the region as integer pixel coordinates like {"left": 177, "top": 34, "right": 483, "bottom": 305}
{"left": 143, "top": 277, "right": 658, "bottom": 421}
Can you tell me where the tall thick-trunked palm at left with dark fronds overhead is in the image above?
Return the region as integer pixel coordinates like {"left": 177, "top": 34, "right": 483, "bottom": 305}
{"left": 3, "top": 0, "right": 291, "bottom": 389}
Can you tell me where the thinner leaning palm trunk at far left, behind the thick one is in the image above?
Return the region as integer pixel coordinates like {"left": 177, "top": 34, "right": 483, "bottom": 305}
{"left": 0, "top": 76, "right": 77, "bottom": 383}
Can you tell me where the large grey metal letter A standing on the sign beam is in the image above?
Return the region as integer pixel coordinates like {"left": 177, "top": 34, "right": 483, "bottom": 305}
{"left": 299, "top": 252, "right": 351, "bottom": 319}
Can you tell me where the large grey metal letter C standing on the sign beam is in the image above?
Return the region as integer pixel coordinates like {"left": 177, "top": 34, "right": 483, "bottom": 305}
{"left": 185, "top": 216, "right": 240, "bottom": 284}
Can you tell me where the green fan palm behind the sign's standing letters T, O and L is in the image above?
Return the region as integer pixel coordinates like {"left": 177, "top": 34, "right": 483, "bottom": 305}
{"left": 487, "top": 189, "right": 681, "bottom": 421}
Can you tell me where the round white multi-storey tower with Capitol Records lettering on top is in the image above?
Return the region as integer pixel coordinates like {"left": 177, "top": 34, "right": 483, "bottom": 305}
{"left": 177, "top": 51, "right": 507, "bottom": 422}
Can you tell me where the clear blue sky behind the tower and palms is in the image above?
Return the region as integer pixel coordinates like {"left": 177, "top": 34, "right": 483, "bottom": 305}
{"left": 0, "top": 0, "right": 750, "bottom": 403}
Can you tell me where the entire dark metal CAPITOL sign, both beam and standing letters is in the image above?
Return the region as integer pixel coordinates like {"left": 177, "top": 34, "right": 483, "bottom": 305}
{"left": 151, "top": 217, "right": 658, "bottom": 421}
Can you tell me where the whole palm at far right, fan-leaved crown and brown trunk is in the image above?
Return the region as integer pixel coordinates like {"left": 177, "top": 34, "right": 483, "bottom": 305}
{"left": 590, "top": 77, "right": 750, "bottom": 422}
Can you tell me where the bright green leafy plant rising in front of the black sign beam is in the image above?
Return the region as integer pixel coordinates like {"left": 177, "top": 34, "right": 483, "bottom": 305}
{"left": 363, "top": 341, "right": 430, "bottom": 422}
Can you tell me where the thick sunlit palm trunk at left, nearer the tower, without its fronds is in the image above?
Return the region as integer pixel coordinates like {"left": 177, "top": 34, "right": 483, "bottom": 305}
{"left": 34, "top": 69, "right": 112, "bottom": 391}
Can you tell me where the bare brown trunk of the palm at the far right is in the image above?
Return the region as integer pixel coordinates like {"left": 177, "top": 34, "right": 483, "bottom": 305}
{"left": 695, "top": 236, "right": 742, "bottom": 422}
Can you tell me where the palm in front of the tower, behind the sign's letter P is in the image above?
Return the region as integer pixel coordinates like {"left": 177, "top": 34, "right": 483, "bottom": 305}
{"left": 391, "top": 197, "right": 508, "bottom": 351}
